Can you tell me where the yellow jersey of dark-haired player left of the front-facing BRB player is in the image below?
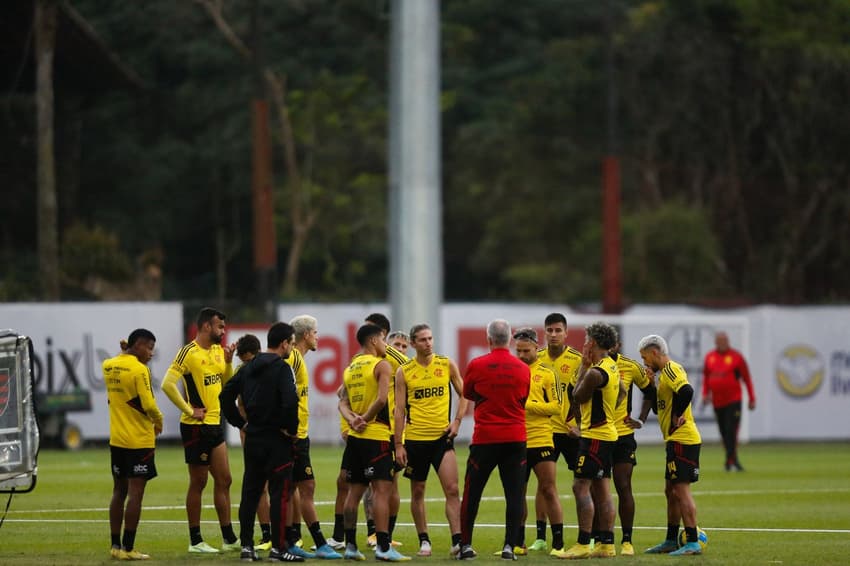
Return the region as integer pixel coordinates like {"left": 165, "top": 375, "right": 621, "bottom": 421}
{"left": 342, "top": 354, "right": 392, "bottom": 441}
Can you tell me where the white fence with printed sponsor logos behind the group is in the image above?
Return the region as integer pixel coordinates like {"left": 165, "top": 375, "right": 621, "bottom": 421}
{"left": 0, "top": 303, "right": 850, "bottom": 443}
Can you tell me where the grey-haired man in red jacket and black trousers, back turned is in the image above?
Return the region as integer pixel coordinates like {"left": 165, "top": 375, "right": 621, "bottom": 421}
{"left": 458, "top": 319, "right": 531, "bottom": 560}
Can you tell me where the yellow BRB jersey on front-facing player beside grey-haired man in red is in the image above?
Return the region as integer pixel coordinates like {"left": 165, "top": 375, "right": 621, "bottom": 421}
{"left": 399, "top": 354, "right": 452, "bottom": 440}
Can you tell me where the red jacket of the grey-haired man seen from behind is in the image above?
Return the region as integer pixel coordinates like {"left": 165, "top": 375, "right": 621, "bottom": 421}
{"left": 463, "top": 348, "right": 531, "bottom": 444}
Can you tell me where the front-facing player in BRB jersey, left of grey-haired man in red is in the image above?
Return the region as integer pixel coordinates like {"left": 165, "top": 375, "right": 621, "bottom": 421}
{"left": 395, "top": 324, "right": 469, "bottom": 556}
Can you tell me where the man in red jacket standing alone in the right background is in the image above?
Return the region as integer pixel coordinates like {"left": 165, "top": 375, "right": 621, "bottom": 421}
{"left": 702, "top": 331, "right": 756, "bottom": 472}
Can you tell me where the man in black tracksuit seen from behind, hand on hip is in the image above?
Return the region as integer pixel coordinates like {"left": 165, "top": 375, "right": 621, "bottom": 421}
{"left": 219, "top": 322, "right": 304, "bottom": 562}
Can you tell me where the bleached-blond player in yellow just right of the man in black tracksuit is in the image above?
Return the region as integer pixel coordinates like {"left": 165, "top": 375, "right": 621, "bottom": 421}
{"left": 287, "top": 314, "right": 342, "bottom": 559}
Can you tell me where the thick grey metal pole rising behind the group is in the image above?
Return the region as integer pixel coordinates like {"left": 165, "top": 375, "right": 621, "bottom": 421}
{"left": 388, "top": 0, "right": 443, "bottom": 342}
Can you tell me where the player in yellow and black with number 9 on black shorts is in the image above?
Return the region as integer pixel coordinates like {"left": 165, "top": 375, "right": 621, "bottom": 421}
{"left": 558, "top": 322, "right": 626, "bottom": 558}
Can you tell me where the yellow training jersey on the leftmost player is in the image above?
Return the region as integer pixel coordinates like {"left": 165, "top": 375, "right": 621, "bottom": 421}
{"left": 102, "top": 354, "right": 162, "bottom": 448}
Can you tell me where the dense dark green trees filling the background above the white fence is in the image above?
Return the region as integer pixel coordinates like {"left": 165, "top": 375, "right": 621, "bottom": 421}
{"left": 0, "top": 0, "right": 850, "bottom": 304}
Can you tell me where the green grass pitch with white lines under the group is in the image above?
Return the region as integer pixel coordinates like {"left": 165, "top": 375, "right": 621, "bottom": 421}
{"left": 0, "top": 443, "right": 850, "bottom": 565}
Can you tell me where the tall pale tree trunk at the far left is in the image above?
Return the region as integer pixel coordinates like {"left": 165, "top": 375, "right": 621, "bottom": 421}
{"left": 34, "top": 0, "right": 59, "bottom": 301}
